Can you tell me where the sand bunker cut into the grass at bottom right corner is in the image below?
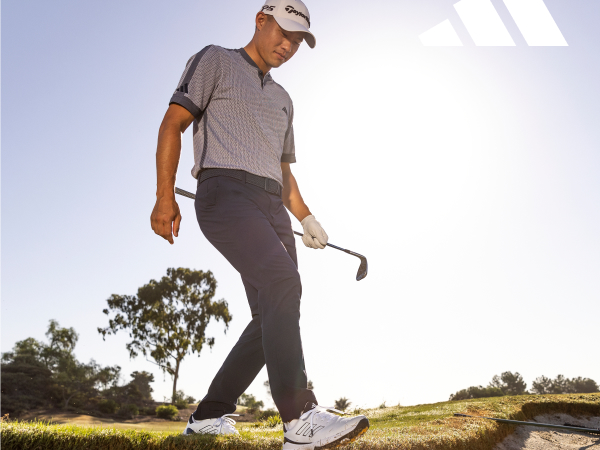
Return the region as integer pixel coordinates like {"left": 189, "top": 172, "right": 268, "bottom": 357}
{"left": 494, "top": 414, "right": 600, "bottom": 450}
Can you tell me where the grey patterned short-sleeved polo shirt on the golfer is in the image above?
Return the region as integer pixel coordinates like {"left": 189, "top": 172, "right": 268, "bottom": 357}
{"left": 169, "top": 45, "right": 296, "bottom": 185}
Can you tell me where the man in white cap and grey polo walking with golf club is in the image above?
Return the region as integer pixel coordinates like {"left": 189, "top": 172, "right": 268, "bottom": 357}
{"left": 151, "top": 0, "right": 369, "bottom": 449}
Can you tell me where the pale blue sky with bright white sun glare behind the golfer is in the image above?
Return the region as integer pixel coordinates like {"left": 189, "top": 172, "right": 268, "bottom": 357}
{"left": 1, "top": 0, "right": 600, "bottom": 407}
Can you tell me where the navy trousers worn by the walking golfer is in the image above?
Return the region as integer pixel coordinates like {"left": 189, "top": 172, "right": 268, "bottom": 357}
{"left": 194, "top": 176, "right": 317, "bottom": 422}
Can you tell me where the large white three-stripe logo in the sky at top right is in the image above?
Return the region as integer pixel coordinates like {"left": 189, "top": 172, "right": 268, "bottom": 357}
{"left": 419, "top": 0, "right": 569, "bottom": 47}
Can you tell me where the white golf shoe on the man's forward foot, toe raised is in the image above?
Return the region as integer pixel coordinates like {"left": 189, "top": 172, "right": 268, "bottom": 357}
{"left": 283, "top": 405, "right": 369, "bottom": 450}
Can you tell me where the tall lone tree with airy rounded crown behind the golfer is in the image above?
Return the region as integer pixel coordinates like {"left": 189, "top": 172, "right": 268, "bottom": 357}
{"left": 98, "top": 268, "right": 232, "bottom": 400}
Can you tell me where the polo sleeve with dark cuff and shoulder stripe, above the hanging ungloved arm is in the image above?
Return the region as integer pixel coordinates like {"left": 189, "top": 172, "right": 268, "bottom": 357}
{"left": 169, "top": 45, "right": 222, "bottom": 119}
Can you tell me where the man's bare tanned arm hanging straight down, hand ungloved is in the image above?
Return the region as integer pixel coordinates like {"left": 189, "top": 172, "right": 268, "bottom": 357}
{"left": 150, "top": 104, "right": 194, "bottom": 244}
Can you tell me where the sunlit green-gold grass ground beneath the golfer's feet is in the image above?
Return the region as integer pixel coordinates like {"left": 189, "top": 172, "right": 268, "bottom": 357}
{"left": 0, "top": 394, "right": 600, "bottom": 450}
